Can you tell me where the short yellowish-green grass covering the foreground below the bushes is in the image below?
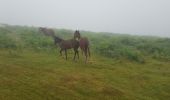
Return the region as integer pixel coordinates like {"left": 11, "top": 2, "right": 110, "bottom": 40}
{"left": 0, "top": 49, "right": 170, "bottom": 100}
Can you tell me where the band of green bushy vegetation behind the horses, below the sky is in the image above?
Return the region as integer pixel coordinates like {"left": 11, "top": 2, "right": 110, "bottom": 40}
{"left": 0, "top": 26, "right": 170, "bottom": 62}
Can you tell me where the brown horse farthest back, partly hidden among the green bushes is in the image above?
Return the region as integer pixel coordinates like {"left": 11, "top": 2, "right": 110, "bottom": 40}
{"left": 39, "top": 27, "right": 55, "bottom": 37}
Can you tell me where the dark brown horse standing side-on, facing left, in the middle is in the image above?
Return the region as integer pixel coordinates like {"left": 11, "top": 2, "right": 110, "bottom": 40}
{"left": 54, "top": 36, "right": 79, "bottom": 60}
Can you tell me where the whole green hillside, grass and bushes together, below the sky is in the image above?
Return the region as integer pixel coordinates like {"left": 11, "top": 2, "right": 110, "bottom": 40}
{"left": 0, "top": 25, "right": 170, "bottom": 100}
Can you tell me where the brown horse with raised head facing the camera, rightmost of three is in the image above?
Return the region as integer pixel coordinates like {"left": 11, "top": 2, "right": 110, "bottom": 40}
{"left": 74, "top": 30, "right": 90, "bottom": 62}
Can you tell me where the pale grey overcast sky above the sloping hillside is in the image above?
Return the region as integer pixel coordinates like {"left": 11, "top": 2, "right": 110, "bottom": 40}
{"left": 0, "top": 0, "right": 170, "bottom": 37}
